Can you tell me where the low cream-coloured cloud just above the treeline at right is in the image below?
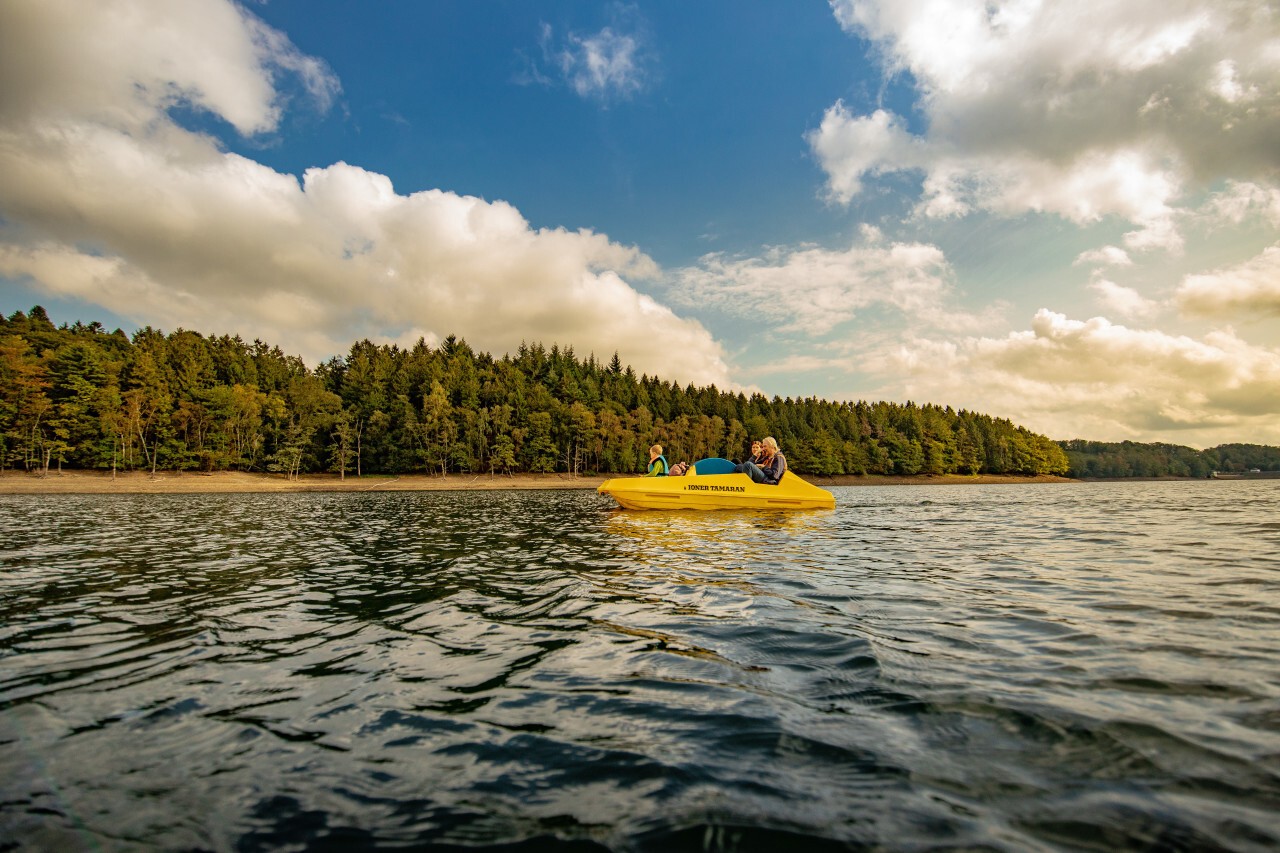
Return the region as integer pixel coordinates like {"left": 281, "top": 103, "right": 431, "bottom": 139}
{"left": 884, "top": 309, "right": 1280, "bottom": 444}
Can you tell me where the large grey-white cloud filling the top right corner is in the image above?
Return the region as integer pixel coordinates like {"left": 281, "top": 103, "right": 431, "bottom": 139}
{"left": 809, "top": 0, "right": 1280, "bottom": 244}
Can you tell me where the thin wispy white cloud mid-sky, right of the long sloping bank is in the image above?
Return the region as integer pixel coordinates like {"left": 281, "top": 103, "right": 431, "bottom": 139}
{"left": 673, "top": 228, "right": 998, "bottom": 336}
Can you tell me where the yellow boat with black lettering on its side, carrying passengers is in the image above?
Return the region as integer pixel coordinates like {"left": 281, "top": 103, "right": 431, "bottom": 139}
{"left": 595, "top": 462, "right": 836, "bottom": 510}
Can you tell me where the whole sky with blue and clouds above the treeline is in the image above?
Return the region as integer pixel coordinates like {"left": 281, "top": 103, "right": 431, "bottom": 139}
{"left": 0, "top": 0, "right": 1280, "bottom": 447}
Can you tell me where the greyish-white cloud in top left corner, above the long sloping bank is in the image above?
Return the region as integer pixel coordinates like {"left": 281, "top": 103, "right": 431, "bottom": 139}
{"left": 0, "top": 0, "right": 340, "bottom": 133}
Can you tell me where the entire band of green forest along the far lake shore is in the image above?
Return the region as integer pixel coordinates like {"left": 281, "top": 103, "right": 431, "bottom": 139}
{"left": 0, "top": 306, "right": 1280, "bottom": 478}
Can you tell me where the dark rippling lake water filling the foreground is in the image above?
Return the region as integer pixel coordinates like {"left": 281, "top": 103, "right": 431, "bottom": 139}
{"left": 0, "top": 480, "right": 1280, "bottom": 852}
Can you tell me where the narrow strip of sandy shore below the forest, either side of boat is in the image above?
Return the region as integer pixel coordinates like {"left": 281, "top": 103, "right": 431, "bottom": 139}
{"left": 0, "top": 470, "right": 1078, "bottom": 494}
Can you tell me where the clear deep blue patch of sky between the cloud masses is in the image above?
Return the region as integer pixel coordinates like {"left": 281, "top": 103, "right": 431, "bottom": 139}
{"left": 235, "top": 1, "right": 885, "bottom": 272}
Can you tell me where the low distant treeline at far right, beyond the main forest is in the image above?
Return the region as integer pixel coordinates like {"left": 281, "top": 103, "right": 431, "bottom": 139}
{"left": 1059, "top": 438, "right": 1280, "bottom": 479}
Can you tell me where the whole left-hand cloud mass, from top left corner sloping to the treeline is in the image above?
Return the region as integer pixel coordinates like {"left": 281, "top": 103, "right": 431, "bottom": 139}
{"left": 0, "top": 0, "right": 731, "bottom": 386}
